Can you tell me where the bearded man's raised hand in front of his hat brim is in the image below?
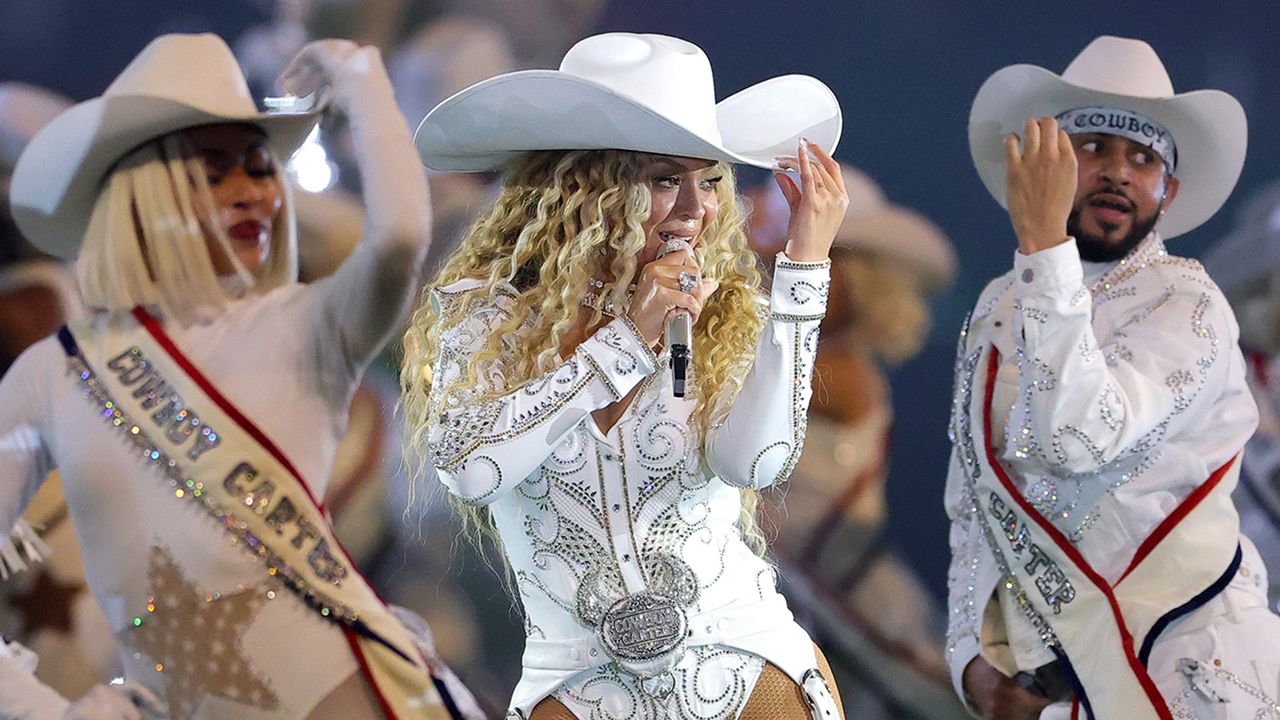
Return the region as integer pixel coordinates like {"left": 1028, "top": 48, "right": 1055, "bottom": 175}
{"left": 1005, "top": 118, "right": 1076, "bottom": 255}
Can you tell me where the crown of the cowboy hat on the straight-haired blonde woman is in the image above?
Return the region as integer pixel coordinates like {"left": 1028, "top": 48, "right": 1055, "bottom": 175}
{"left": 102, "top": 33, "right": 257, "bottom": 115}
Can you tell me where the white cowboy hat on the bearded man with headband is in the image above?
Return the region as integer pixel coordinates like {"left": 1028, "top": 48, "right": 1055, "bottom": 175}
{"left": 969, "top": 36, "right": 1248, "bottom": 238}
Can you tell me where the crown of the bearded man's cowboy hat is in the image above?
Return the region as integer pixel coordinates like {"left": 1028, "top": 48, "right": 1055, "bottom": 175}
{"left": 1062, "top": 35, "right": 1174, "bottom": 99}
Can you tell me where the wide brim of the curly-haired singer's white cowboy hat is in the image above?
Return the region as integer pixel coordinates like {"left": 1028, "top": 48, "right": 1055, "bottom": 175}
{"left": 413, "top": 70, "right": 841, "bottom": 172}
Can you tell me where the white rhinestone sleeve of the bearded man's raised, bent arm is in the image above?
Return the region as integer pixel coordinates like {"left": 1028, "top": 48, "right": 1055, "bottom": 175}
{"left": 1009, "top": 241, "right": 1235, "bottom": 473}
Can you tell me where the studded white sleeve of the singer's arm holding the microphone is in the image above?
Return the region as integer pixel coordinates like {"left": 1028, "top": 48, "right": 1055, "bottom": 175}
{"left": 426, "top": 310, "right": 657, "bottom": 505}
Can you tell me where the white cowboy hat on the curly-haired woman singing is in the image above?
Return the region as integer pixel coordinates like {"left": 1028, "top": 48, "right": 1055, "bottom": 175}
{"left": 413, "top": 32, "right": 841, "bottom": 172}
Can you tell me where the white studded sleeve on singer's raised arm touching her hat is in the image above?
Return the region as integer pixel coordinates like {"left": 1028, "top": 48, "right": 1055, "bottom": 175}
{"left": 707, "top": 252, "right": 831, "bottom": 488}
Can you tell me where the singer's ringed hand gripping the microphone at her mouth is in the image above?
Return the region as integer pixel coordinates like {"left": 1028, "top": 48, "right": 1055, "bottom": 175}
{"left": 627, "top": 247, "right": 719, "bottom": 347}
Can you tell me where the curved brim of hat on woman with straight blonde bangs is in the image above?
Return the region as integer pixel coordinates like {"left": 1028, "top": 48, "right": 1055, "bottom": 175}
{"left": 10, "top": 95, "right": 323, "bottom": 259}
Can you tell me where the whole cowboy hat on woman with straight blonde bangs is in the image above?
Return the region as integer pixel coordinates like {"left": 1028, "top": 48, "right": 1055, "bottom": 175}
{"left": 10, "top": 35, "right": 321, "bottom": 258}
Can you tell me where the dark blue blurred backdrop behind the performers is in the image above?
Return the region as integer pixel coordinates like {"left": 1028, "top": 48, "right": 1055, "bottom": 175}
{"left": 0, "top": 0, "right": 1280, "bottom": 593}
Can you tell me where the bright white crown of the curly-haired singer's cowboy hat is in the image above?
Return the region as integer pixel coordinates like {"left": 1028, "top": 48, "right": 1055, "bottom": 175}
{"left": 559, "top": 32, "right": 721, "bottom": 143}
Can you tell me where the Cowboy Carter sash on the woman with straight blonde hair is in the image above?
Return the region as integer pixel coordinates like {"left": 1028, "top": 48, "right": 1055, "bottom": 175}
{"left": 58, "top": 307, "right": 461, "bottom": 720}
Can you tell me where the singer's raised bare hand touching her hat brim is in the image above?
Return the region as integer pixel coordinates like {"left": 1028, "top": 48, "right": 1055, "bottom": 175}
{"left": 773, "top": 140, "right": 849, "bottom": 263}
